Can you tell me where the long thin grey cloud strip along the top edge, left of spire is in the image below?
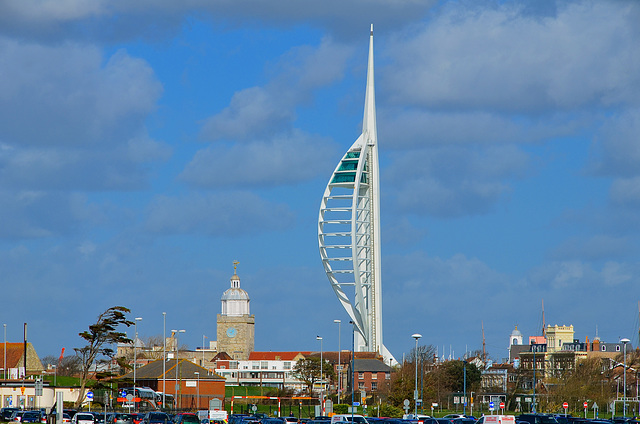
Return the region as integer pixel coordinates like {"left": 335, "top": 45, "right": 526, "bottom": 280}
{"left": 0, "top": 0, "right": 435, "bottom": 40}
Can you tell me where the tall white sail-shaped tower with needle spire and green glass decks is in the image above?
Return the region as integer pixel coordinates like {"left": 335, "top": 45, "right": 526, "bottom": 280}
{"left": 318, "top": 25, "right": 396, "bottom": 363}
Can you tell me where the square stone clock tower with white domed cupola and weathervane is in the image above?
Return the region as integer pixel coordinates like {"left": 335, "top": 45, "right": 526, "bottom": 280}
{"left": 217, "top": 261, "right": 255, "bottom": 360}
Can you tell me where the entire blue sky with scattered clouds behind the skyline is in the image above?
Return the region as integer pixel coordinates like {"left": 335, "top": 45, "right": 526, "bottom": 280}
{"left": 0, "top": 0, "right": 640, "bottom": 359}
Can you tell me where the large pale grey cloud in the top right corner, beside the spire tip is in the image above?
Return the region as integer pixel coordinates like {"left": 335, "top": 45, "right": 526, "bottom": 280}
{"left": 384, "top": 2, "right": 640, "bottom": 114}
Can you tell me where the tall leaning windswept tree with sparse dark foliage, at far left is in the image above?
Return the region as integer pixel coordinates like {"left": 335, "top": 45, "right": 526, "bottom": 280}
{"left": 74, "top": 306, "right": 133, "bottom": 408}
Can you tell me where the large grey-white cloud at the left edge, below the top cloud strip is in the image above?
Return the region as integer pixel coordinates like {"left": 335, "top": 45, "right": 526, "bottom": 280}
{"left": 0, "top": 38, "right": 170, "bottom": 190}
